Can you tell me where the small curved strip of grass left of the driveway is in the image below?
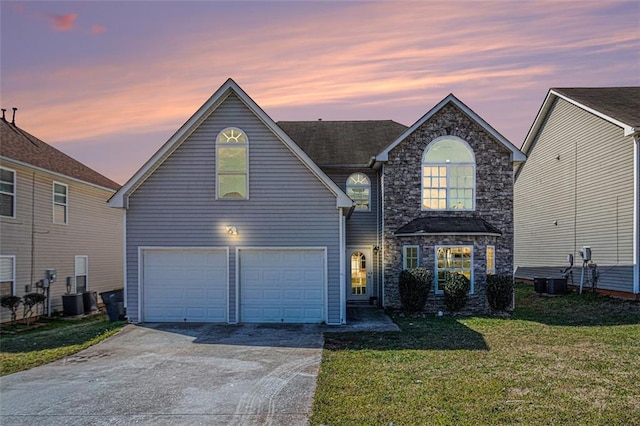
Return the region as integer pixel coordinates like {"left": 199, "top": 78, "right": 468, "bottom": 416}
{"left": 0, "top": 315, "right": 124, "bottom": 376}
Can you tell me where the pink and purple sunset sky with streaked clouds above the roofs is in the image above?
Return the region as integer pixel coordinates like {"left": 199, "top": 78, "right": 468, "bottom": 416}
{"left": 0, "top": 0, "right": 640, "bottom": 183}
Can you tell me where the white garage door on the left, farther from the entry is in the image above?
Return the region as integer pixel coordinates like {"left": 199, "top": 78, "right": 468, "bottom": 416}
{"left": 142, "top": 249, "right": 228, "bottom": 322}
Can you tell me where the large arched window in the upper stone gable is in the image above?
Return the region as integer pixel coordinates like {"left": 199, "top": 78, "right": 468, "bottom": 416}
{"left": 422, "top": 136, "right": 476, "bottom": 210}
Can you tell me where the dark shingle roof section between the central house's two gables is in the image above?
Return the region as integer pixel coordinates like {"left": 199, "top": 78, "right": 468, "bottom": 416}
{"left": 278, "top": 120, "right": 407, "bottom": 166}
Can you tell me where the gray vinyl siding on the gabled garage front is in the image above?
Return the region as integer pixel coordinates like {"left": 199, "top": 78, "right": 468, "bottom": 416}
{"left": 127, "top": 95, "right": 342, "bottom": 323}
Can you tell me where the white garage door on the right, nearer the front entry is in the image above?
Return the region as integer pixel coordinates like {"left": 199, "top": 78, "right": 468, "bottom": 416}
{"left": 240, "top": 249, "right": 325, "bottom": 323}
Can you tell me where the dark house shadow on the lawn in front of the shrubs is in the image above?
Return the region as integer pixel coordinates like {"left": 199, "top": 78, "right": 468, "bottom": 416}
{"left": 324, "top": 317, "right": 489, "bottom": 351}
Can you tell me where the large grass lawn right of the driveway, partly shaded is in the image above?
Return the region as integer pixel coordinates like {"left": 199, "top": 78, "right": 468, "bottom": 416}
{"left": 311, "top": 286, "right": 640, "bottom": 426}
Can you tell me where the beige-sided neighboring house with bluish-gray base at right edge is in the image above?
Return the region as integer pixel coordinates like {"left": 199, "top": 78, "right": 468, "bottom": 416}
{"left": 515, "top": 87, "right": 640, "bottom": 298}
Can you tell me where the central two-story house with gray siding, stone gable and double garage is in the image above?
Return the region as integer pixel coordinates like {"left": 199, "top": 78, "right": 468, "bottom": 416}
{"left": 109, "top": 80, "right": 525, "bottom": 324}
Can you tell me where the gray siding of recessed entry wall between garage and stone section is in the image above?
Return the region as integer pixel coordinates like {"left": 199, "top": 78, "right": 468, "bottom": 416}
{"left": 323, "top": 168, "right": 381, "bottom": 297}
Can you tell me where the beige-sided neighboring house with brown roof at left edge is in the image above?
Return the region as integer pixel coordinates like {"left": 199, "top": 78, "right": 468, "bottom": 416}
{"left": 0, "top": 117, "right": 124, "bottom": 321}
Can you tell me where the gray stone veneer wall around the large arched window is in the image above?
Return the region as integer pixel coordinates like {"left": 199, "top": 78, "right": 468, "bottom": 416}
{"left": 382, "top": 104, "right": 513, "bottom": 312}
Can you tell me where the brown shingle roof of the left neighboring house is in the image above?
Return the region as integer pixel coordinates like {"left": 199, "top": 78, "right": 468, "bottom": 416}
{"left": 0, "top": 119, "right": 120, "bottom": 190}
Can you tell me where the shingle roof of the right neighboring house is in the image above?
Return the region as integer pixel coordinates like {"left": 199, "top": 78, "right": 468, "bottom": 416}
{"left": 552, "top": 86, "right": 640, "bottom": 127}
